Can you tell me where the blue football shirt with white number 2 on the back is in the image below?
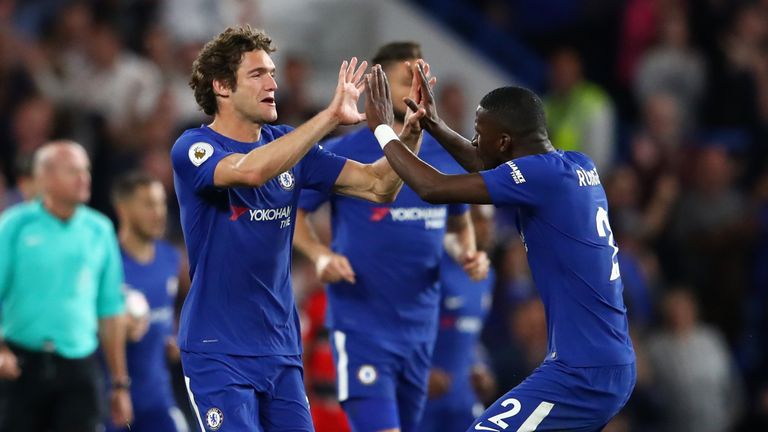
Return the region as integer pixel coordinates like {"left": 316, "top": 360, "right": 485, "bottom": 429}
{"left": 480, "top": 151, "right": 635, "bottom": 367}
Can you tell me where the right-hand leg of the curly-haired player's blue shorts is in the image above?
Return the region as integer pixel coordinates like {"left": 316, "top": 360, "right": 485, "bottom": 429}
{"left": 259, "top": 365, "right": 315, "bottom": 432}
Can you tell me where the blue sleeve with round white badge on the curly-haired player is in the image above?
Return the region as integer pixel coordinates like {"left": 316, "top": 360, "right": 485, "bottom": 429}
{"left": 171, "top": 135, "right": 232, "bottom": 192}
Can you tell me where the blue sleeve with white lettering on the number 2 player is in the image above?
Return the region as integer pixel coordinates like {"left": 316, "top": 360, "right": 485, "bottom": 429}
{"left": 480, "top": 155, "right": 551, "bottom": 207}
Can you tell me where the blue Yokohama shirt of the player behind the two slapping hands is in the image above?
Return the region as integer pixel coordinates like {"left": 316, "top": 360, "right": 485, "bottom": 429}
{"left": 299, "top": 128, "right": 468, "bottom": 341}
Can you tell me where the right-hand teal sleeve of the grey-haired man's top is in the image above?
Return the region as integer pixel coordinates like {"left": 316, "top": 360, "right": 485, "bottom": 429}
{"left": 96, "top": 224, "right": 125, "bottom": 318}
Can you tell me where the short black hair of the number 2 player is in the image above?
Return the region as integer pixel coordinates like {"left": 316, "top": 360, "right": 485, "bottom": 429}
{"left": 480, "top": 86, "right": 547, "bottom": 136}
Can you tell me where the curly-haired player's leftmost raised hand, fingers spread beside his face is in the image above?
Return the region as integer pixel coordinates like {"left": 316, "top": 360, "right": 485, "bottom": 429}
{"left": 328, "top": 57, "right": 368, "bottom": 125}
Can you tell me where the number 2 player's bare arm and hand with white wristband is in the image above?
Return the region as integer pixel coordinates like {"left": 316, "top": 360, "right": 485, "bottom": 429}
{"left": 365, "top": 67, "right": 491, "bottom": 204}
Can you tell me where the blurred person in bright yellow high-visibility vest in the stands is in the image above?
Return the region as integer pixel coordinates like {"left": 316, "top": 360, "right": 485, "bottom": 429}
{"left": 544, "top": 48, "right": 616, "bottom": 172}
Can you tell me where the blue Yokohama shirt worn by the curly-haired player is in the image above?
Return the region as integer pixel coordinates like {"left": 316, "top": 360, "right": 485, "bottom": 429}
{"left": 171, "top": 125, "right": 346, "bottom": 356}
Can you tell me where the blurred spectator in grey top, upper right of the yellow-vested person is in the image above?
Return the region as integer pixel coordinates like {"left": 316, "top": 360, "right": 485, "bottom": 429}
{"left": 635, "top": 9, "right": 706, "bottom": 128}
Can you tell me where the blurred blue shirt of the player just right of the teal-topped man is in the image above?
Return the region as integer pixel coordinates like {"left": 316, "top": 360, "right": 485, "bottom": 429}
{"left": 121, "top": 241, "right": 179, "bottom": 412}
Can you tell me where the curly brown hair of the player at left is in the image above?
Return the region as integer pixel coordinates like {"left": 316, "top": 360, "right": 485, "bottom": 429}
{"left": 189, "top": 24, "right": 275, "bottom": 115}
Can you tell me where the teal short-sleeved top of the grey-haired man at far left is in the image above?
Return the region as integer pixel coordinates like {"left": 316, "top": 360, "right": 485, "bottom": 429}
{"left": 0, "top": 201, "right": 124, "bottom": 358}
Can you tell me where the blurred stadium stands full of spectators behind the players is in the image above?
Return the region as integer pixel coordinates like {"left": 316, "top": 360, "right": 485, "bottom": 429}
{"left": 0, "top": 0, "right": 768, "bottom": 431}
